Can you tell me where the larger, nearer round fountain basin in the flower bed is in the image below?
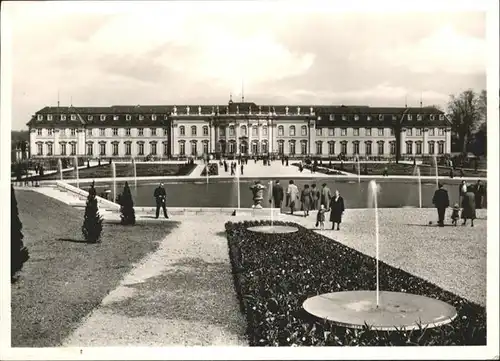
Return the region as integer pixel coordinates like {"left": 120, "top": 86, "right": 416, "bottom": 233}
{"left": 303, "top": 291, "right": 457, "bottom": 331}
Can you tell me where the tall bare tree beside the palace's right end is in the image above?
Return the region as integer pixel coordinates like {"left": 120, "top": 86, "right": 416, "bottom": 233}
{"left": 448, "top": 89, "right": 486, "bottom": 154}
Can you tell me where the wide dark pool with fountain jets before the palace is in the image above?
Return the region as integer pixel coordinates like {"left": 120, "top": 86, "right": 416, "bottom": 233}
{"left": 88, "top": 178, "right": 486, "bottom": 209}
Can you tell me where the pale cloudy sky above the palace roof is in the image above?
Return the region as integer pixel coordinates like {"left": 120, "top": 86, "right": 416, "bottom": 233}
{"left": 3, "top": 0, "right": 486, "bottom": 129}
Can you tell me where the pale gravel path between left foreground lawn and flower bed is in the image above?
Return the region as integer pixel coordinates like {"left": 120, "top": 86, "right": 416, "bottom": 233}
{"left": 64, "top": 216, "right": 247, "bottom": 347}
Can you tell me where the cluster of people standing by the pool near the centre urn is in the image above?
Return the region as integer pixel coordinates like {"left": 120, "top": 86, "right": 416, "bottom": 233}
{"left": 269, "top": 180, "right": 345, "bottom": 230}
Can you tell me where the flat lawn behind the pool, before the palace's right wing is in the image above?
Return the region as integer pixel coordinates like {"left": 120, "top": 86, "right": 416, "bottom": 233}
{"left": 318, "top": 162, "right": 487, "bottom": 178}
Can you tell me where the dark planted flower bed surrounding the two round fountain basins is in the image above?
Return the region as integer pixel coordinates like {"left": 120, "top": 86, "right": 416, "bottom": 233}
{"left": 226, "top": 221, "right": 486, "bottom": 346}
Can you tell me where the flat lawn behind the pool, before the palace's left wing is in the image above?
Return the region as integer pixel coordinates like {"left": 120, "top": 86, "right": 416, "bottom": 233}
{"left": 26, "top": 163, "right": 196, "bottom": 180}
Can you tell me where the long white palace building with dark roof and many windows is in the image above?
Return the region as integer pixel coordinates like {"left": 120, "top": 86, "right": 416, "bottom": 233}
{"left": 28, "top": 100, "right": 451, "bottom": 158}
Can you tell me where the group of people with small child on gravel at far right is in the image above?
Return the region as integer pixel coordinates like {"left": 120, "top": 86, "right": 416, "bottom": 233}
{"left": 432, "top": 180, "right": 485, "bottom": 227}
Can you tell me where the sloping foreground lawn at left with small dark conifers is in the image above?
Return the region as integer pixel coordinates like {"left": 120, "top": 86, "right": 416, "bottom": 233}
{"left": 11, "top": 190, "right": 180, "bottom": 347}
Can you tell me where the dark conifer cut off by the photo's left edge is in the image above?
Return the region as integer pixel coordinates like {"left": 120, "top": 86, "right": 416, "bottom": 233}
{"left": 10, "top": 185, "right": 30, "bottom": 282}
